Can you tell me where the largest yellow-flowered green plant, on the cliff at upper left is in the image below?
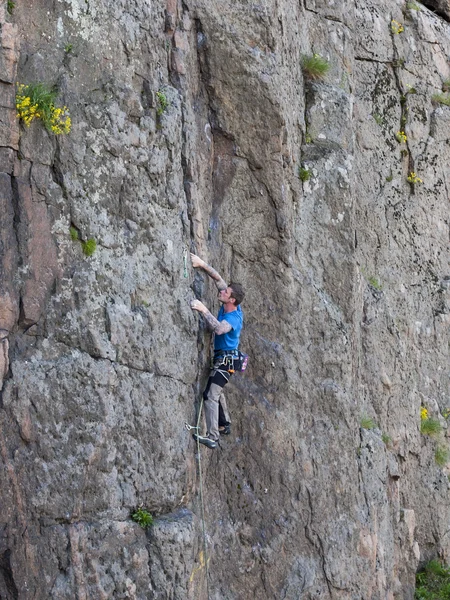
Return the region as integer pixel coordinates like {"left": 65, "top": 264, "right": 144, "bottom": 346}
{"left": 16, "top": 83, "right": 72, "bottom": 135}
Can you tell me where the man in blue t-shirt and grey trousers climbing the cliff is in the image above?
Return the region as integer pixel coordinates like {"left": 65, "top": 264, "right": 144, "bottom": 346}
{"left": 191, "top": 253, "right": 244, "bottom": 448}
